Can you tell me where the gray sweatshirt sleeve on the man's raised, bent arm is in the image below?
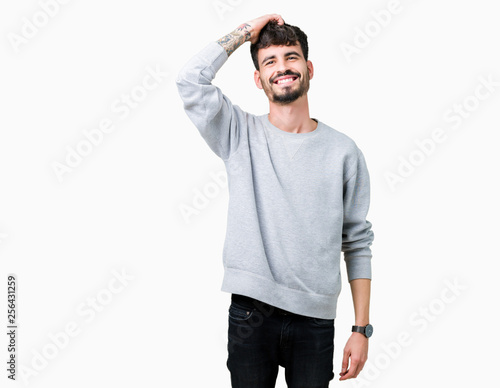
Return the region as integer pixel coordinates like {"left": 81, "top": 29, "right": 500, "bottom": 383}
{"left": 176, "top": 41, "right": 244, "bottom": 160}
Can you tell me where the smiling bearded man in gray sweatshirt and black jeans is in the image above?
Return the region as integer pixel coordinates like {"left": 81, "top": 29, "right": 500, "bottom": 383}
{"left": 176, "top": 14, "right": 373, "bottom": 388}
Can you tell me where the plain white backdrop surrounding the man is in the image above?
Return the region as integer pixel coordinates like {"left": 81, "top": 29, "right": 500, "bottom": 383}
{"left": 0, "top": 0, "right": 500, "bottom": 388}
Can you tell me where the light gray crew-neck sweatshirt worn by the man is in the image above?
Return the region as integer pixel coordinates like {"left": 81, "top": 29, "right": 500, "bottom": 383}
{"left": 176, "top": 41, "right": 373, "bottom": 319}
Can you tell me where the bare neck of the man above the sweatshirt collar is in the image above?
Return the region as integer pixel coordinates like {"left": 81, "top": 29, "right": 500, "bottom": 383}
{"left": 269, "top": 94, "right": 318, "bottom": 133}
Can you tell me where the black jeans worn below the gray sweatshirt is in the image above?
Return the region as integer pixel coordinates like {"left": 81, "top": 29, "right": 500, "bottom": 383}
{"left": 227, "top": 294, "right": 335, "bottom": 388}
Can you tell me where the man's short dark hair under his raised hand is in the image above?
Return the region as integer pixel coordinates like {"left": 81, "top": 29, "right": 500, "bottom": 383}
{"left": 250, "top": 20, "right": 309, "bottom": 70}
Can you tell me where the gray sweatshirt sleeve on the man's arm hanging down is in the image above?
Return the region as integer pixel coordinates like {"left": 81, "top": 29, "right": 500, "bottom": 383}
{"left": 342, "top": 147, "right": 374, "bottom": 282}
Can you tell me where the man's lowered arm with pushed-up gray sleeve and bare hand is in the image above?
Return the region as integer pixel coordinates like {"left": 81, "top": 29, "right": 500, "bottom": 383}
{"left": 340, "top": 148, "right": 374, "bottom": 380}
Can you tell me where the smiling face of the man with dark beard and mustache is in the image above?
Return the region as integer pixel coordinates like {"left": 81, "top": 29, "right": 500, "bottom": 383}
{"left": 254, "top": 44, "right": 313, "bottom": 105}
